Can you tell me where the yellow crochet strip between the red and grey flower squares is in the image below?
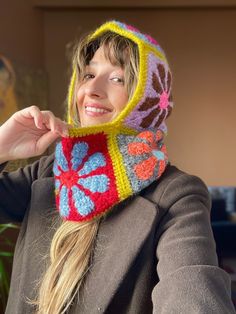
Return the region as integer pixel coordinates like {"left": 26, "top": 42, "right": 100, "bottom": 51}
{"left": 107, "top": 134, "right": 133, "bottom": 201}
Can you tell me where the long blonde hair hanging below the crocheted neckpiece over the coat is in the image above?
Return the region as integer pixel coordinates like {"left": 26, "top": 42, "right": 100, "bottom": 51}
{"left": 28, "top": 217, "right": 101, "bottom": 314}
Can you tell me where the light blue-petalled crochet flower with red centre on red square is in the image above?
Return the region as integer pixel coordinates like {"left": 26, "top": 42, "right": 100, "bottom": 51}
{"left": 53, "top": 142, "right": 109, "bottom": 217}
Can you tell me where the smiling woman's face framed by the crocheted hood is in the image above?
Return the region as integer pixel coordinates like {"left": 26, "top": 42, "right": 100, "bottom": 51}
{"left": 77, "top": 47, "right": 128, "bottom": 127}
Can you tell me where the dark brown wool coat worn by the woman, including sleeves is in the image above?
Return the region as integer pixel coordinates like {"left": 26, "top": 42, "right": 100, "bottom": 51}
{"left": 0, "top": 155, "right": 235, "bottom": 314}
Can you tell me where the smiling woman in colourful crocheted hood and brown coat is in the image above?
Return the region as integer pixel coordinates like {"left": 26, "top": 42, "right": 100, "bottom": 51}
{"left": 0, "top": 21, "right": 234, "bottom": 314}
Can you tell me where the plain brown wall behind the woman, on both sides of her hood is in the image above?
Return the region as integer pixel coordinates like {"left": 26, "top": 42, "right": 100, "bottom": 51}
{"left": 45, "top": 9, "right": 236, "bottom": 185}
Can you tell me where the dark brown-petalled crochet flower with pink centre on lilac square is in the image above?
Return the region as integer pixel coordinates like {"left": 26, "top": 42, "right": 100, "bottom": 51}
{"left": 138, "top": 63, "right": 172, "bottom": 129}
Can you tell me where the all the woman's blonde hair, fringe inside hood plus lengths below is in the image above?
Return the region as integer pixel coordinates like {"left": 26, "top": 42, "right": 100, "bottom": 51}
{"left": 29, "top": 32, "right": 138, "bottom": 314}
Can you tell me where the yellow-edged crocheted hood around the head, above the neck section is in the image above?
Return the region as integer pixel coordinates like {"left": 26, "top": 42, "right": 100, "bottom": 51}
{"left": 68, "top": 21, "right": 173, "bottom": 133}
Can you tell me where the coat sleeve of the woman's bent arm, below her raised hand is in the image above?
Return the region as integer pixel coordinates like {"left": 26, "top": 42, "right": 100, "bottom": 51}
{"left": 0, "top": 156, "right": 51, "bottom": 223}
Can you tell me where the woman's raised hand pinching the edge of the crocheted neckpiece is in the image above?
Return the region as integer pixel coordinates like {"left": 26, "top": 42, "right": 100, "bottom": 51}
{"left": 0, "top": 106, "right": 68, "bottom": 163}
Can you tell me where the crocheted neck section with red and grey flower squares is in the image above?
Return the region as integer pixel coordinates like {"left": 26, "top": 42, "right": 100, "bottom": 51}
{"left": 54, "top": 130, "right": 167, "bottom": 221}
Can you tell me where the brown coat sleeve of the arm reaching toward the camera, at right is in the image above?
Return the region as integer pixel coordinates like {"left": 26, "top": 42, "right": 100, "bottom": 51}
{"left": 152, "top": 174, "right": 236, "bottom": 314}
